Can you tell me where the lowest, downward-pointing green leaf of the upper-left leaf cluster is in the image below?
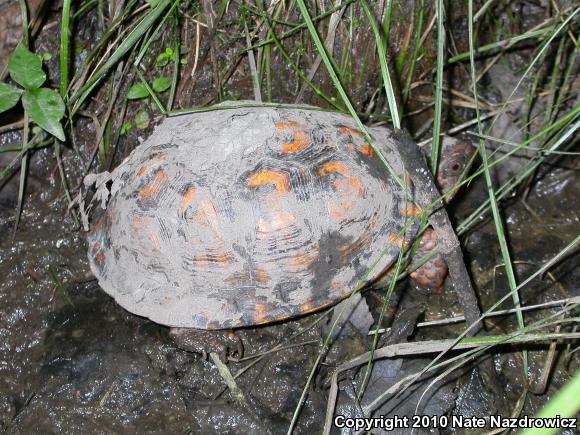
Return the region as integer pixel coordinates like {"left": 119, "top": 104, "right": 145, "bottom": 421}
{"left": 22, "top": 88, "right": 65, "bottom": 141}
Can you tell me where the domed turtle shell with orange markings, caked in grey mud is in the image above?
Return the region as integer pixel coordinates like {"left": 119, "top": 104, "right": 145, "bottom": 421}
{"left": 89, "top": 106, "right": 416, "bottom": 329}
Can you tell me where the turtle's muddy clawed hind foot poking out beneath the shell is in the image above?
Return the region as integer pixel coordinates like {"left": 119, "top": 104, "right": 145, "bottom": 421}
{"left": 169, "top": 328, "right": 244, "bottom": 362}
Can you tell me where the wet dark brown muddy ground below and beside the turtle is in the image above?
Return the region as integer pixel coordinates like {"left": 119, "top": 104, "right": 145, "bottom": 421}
{"left": 0, "top": 127, "right": 580, "bottom": 433}
